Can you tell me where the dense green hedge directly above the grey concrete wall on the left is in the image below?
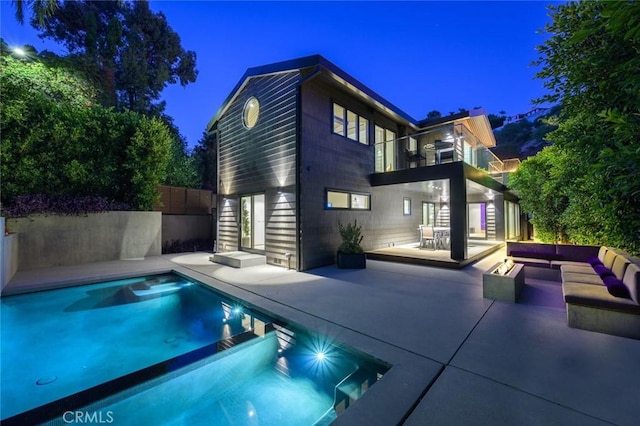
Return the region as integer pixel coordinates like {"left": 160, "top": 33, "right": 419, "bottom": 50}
{"left": 0, "top": 56, "right": 171, "bottom": 209}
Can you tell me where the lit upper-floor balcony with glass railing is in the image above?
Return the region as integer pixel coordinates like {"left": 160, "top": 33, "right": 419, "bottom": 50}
{"left": 375, "top": 124, "right": 519, "bottom": 183}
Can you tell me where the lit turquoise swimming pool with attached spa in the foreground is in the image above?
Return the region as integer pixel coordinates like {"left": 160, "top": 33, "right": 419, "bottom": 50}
{"left": 0, "top": 273, "right": 387, "bottom": 424}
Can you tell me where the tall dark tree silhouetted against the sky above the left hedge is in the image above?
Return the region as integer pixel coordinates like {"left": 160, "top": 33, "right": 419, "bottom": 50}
{"left": 31, "top": 0, "right": 197, "bottom": 114}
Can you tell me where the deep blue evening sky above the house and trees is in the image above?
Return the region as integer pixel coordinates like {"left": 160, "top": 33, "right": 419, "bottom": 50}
{"left": 0, "top": 1, "right": 550, "bottom": 151}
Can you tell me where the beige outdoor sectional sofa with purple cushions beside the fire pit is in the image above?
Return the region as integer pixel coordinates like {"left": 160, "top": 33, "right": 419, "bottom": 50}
{"left": 507, "top": 243, "right": 640, "bottom": 339}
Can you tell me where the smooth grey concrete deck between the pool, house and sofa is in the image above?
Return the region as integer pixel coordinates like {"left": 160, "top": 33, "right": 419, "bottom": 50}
{"left": 3, "top": 249, "right": 640, "bottom": 426}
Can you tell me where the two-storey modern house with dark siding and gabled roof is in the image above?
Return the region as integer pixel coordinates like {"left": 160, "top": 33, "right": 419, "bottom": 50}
{"left": 207, "top": 55, "right": 520, "bottom": 270}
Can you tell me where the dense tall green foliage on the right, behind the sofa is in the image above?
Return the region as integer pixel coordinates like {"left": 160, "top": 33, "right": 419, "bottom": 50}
{"left": 512, "top": 1, "right": 640, "bottom": 254}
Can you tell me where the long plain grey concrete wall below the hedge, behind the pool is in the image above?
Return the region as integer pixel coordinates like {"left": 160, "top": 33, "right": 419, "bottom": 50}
{"left": 7, "top": 212, "right": 162, "bottom": 270}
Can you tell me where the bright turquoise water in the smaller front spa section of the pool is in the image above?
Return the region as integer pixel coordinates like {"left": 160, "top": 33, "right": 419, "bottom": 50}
{"left": 51, "top": 332, "right": 335, "bottom": 426}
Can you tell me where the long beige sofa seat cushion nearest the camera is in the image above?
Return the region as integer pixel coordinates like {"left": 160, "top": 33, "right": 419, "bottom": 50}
{"left": 562, "top": 282, "right": 640, "bottom": 315}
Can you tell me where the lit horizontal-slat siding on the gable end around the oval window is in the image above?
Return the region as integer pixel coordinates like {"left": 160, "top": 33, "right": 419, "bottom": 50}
{"left": 218, "top": 72, "right": 300, "bottom": 267}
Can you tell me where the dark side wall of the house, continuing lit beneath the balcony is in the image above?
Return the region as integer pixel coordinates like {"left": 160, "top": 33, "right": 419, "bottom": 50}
{"left": 300, "top": 79, "right": 444, "bottom": 269}
